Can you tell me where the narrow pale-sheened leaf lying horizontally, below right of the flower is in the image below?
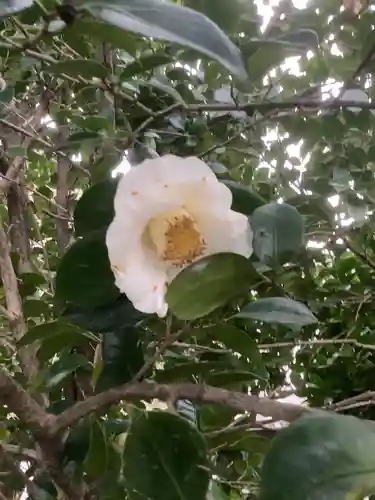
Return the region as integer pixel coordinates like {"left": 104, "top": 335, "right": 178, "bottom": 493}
{"left": 236, "top": 297, "right": 318, "bottom": 327}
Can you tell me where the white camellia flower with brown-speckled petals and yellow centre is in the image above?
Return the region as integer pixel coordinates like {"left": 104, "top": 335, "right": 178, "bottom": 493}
{"left": 106, "top": 155, "right": 252, "bottom": 317}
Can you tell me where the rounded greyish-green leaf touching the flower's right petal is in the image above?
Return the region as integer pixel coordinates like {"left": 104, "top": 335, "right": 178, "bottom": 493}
{"left": 251, "top": 203, "right": 304, "bottom": 265}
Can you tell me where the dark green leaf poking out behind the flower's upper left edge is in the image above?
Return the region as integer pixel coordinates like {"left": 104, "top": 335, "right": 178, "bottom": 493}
{"left": 74, "top": 179, "right": 117, "bottom": 236}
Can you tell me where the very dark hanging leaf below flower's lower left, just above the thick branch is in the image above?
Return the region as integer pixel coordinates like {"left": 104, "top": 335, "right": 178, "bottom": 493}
{"left": 96, "top": 327, "right": 145, "bottom": 392}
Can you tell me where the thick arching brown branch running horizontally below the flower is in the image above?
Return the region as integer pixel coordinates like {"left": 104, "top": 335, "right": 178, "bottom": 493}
{"left": 51, "top": 382, "right": 312, "bottom": 434}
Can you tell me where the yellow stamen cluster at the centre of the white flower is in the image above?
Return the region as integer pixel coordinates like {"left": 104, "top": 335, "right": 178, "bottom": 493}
{"left": 146, "top": 208, "right": 206, "bottom": 267}
